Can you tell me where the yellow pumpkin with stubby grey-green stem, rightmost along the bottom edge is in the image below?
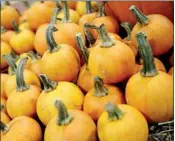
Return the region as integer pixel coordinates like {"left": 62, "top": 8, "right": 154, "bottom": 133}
{"left": 97, "top": 103, "right": 148, "bottom": 141}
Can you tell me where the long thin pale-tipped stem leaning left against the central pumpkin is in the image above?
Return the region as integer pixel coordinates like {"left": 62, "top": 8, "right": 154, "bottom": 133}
{"left": 76, "top": 33, "right": 89, "bottom": 64}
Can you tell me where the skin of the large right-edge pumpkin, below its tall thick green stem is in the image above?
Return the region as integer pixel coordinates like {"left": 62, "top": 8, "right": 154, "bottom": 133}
{"left": 125, "top": 71, "right": 173, "bottom": 123}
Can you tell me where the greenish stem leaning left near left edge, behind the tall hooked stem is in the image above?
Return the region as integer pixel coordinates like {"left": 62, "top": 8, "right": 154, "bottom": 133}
{"left": 2, "top": 55, "right": 17, "bottom": 75}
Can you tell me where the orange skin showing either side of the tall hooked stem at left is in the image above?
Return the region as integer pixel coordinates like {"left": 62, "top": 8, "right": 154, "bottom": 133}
{"left": 4, "top": 69, "right": 41, "bottom": 98}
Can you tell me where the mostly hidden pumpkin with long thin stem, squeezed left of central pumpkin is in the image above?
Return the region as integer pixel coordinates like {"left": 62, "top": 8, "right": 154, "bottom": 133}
{"left": 76, "top": 33, "right": 94, "bottom": 92}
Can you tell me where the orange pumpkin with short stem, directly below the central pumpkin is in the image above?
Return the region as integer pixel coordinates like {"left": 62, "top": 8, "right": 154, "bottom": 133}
{"left": 83, "top": 76, "right": 125, "bottom": 121}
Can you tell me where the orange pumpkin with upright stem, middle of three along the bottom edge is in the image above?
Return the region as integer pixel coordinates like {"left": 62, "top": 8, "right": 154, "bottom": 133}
{"left": 44, "top": 100, "right": 97, "bottom": 141}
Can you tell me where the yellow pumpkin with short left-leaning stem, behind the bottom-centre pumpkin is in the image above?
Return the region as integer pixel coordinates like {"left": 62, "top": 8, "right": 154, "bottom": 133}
{"left": 37, "top": 75, "right": 84, "bottom": 125}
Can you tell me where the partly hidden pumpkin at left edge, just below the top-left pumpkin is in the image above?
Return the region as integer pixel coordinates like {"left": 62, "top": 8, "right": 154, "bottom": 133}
{"left": 1, "top": 26, "right": 14, "bottom": 44}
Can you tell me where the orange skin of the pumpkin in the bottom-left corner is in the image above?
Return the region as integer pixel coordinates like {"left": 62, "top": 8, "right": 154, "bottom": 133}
{"left": 1, "top": 116, "right": 42, "bottom": 141}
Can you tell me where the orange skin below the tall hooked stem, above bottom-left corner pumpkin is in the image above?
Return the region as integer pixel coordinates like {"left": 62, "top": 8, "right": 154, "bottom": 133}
{"left": 6, "top": 85, "right": 41, "bottom": 119}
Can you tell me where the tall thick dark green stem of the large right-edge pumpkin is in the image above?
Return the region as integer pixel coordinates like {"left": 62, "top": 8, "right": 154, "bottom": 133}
{"left": 136, "top": 32, "right": 158, "bottom": 77}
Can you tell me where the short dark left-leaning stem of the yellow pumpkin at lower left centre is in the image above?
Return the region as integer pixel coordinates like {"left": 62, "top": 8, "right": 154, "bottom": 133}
{"left": 39, "top": 74, "right": 58, "bottom": 93}
